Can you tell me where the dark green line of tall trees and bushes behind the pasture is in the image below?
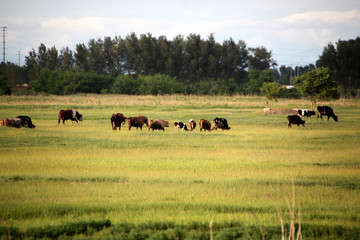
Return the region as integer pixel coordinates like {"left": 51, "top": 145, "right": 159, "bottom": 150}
{"left": 0, "top": 33, "right": 359, "bottom": 94}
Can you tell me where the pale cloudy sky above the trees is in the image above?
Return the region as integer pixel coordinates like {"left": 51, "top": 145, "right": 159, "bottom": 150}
{"left": 0, "top": 0, "right": 360, "bottom": 67}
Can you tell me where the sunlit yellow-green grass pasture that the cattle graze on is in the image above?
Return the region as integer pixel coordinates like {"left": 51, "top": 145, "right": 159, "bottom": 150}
{"left": 0, "top": 95, "right": 360, "bottom": 239}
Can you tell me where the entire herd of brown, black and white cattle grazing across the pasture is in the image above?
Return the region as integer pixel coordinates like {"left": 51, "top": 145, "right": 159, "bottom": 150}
{"left": 0, "top": 106, "right": 338, "bottom": 131}
